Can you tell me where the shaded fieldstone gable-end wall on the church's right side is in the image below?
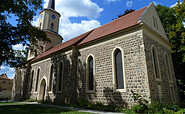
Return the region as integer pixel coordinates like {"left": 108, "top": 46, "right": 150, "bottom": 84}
{"left": 143, "top": 35, "right": 178, "bottom": 102}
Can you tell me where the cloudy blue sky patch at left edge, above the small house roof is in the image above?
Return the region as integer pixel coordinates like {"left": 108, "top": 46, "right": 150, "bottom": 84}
{"left": 0, "top": 66, "right": 15, "bottom": 79}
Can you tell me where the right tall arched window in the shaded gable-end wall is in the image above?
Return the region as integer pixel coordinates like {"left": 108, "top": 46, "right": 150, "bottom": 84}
{"left": 165, "top": 53, "right": 172, "bottom": 81}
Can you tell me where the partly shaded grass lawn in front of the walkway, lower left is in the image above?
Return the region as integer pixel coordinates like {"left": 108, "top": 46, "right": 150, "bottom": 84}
{"left": 0, "top": 103, "right": 89, "bottom": 114}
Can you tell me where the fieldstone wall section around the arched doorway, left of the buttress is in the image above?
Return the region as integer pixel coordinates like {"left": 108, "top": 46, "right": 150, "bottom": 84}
{"left": 30, "top": 51, "right": 76, "bottom": 103}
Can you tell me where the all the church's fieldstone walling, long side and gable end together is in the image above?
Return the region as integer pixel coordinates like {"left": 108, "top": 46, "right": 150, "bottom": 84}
{"left": 26, "top": 29, "right": 178, "bottom": 106}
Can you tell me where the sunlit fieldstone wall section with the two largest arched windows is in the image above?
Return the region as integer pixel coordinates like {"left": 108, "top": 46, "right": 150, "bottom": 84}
{"left": 76, "top": 31, "right": 150, "bottom": 106}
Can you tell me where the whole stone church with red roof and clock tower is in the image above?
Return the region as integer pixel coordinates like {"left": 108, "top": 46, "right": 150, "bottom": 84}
{"left": 12, "top": 0, "right": 179, "bottom": 106}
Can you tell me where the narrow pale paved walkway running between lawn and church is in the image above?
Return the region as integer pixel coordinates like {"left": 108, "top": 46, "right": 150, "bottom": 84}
{"left": 0, "top": 102, "right": 124, "bottom": 114}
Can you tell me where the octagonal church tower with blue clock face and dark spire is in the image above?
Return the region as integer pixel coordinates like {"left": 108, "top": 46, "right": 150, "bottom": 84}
{"left": 28, "top": 0, "right": 63, "bottom": 60}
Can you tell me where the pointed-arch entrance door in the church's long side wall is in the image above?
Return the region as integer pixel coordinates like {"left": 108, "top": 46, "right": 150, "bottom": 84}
{"left": 39, "top": 79, "right": 46, "bottom": 101}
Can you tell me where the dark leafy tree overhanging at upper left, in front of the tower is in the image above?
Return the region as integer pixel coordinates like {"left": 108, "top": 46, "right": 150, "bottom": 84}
{"left": 0, "top": 0, "right": 50, "bottom": 66}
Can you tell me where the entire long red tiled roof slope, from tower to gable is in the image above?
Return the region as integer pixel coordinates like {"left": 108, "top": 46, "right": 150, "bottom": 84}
{"left": 32, "top": 6, "right": 147, "bottom": 61}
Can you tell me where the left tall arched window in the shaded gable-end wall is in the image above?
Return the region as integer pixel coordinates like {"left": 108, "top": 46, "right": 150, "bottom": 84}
{"left": 152, "top": 47, "right": 160, "bottom": 79}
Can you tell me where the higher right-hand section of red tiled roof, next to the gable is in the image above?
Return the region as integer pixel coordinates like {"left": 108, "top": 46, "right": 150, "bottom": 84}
{"left": 78, "top": 7, "right": 146, "bottom": 45}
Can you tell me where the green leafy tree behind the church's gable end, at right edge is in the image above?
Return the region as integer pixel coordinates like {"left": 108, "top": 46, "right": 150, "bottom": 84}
{"left": 156, "top": 0, "right": 185, "bottom": 99}
